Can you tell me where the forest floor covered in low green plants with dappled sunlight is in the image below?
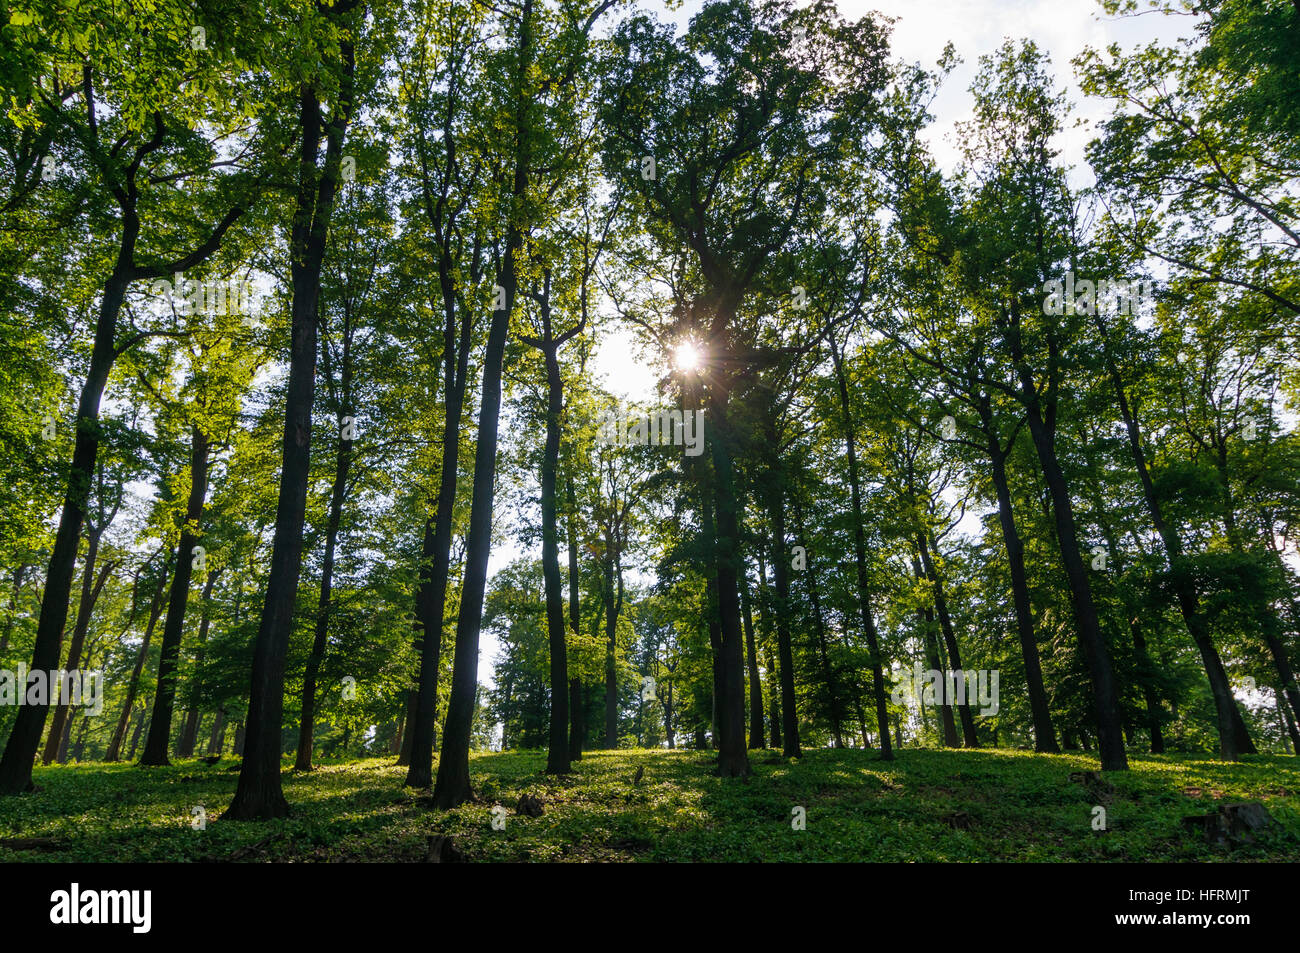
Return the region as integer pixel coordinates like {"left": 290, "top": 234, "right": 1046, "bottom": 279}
{"left": 0, "top": 749, "right": 1300, "bottom": 862}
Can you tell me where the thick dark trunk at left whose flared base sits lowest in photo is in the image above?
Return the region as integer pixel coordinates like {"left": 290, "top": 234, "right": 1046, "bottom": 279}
{"left": 222, "top": 39, "right": 355, "bottom": 820}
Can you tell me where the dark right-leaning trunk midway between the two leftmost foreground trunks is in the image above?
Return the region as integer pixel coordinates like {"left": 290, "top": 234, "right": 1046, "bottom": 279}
{"left": 140, "top": 426, "right": 208, "bottom": 766}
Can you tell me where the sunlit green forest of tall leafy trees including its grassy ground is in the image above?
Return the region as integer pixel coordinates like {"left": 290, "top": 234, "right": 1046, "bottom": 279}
{"left": 0, "top": 0, "right": 1300, "bottom": 861}
